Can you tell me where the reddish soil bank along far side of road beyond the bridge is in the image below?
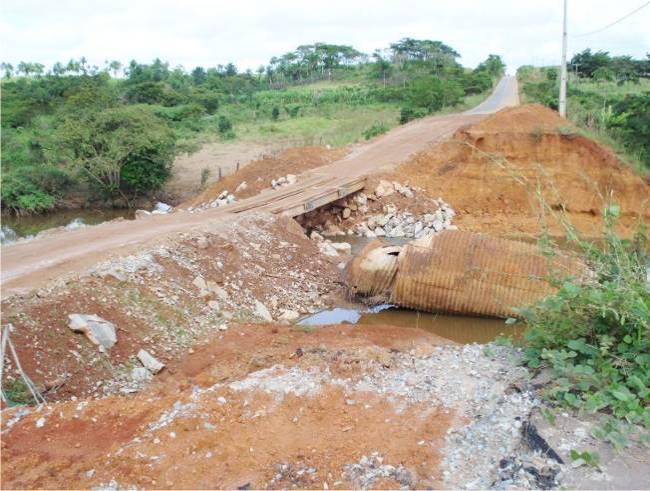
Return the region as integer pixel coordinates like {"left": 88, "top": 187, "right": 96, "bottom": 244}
{"left": 181, "top": 147, "right": 347, "bottom": 208}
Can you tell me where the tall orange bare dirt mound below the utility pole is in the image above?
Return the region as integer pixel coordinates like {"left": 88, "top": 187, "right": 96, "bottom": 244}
{"left": 390, "top": 104, "right": 650, "bottom": 236}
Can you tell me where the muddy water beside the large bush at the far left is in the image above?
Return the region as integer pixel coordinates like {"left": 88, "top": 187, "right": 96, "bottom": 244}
{"left": 2, "top": 208, "right": 135, "bottom": 242}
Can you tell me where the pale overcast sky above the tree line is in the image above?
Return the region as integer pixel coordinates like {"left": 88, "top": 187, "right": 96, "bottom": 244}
{"left": 0, "top": 0, "right": 650, "bottom": 73}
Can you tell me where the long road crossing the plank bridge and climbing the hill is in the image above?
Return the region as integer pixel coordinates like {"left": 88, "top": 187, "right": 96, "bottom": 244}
{"left": 1, "top": 77, "right": 518, "bottom": 298}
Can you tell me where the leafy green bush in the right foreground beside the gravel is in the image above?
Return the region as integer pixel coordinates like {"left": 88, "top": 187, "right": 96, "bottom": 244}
{"left": 520, "top": 206, "right": 650, "bottom": 446}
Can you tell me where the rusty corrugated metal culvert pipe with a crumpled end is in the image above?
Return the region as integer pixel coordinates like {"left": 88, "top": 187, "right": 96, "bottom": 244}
{"left": 347, "top": 230, "right": 588, "bottom": 317}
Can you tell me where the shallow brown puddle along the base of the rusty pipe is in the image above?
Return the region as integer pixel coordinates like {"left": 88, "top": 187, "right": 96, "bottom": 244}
{"left": 299, "top": 305, "right": 522, "bottom": 344}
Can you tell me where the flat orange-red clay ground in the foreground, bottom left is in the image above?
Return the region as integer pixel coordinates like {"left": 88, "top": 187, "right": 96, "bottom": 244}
{"left": 2, "top": 325, "right": 455, "bottom": 489}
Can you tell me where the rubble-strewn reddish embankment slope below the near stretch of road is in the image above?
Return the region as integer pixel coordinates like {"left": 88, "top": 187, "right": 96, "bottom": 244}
{"left": 3, "top": 215, "right": 341, "bottom": 399}
